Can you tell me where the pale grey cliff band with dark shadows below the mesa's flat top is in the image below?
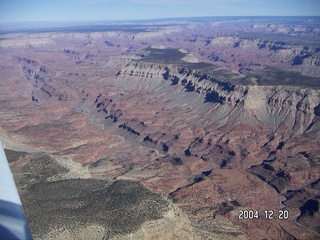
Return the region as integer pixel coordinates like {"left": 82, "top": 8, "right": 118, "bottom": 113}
{"left": 119, "top": 62, "right": 320, "bottom": 132}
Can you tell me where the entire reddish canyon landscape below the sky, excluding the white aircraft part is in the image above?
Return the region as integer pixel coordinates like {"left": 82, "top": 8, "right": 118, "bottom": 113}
{"left": 0, "top": 17, "right": 320, "bottom": 239}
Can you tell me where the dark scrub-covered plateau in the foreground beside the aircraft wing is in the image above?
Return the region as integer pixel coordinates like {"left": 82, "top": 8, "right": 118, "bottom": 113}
{"left": 23, "top": 179, "right": 168, "bottom": 239}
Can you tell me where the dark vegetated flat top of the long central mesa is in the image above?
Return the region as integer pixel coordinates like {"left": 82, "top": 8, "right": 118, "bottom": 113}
{"left": 139, "top": 48, "right": 320, "bottom": 88}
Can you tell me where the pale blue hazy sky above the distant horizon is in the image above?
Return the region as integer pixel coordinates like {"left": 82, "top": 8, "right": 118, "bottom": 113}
{"left": 0, "top": 0, "right": 320, "bottom": 23}
